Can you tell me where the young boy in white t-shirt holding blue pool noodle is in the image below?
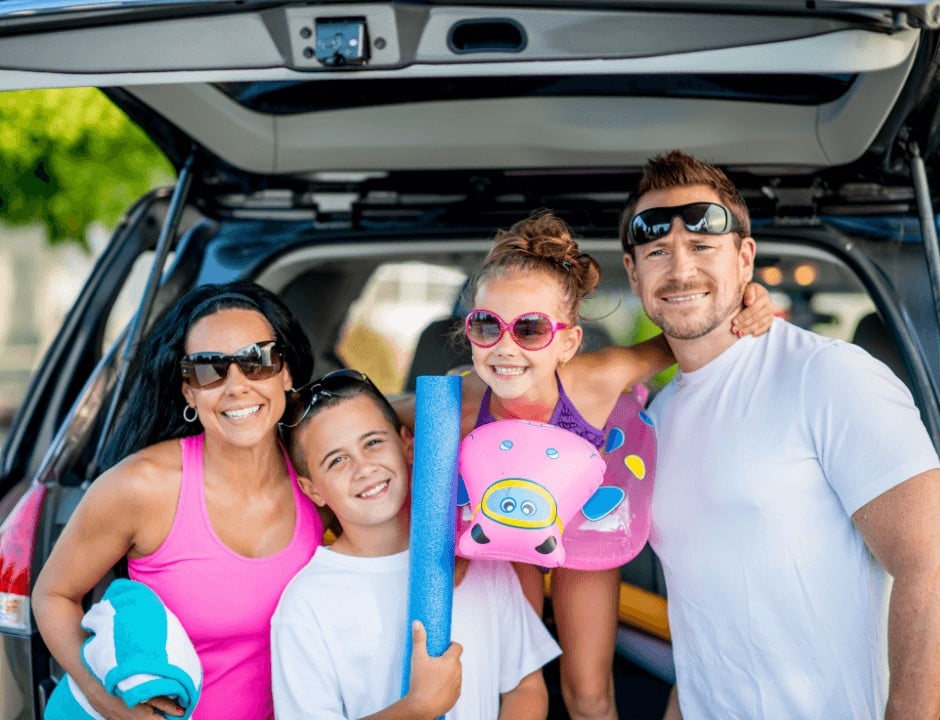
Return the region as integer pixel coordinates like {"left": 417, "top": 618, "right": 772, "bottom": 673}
{"left": 271, "top": 371, "right": 561, "bottom": 720}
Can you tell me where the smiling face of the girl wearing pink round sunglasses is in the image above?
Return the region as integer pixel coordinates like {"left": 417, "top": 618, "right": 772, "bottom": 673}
{"left": 471, "top": 271, "right": 581, "bottom": 406}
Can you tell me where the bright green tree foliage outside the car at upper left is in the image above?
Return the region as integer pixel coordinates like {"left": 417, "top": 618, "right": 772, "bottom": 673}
{"left": 0, "top": 88, "right": 175, "bottom": 248}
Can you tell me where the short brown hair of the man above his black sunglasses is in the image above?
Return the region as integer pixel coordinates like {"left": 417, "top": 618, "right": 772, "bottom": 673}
{"left": 620, "top": 150, "right": 751, "bottom": 255}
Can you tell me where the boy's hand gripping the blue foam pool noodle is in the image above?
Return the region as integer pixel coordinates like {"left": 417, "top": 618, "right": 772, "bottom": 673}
{"left": 408, "top": 620, "right": 463, "bottom": 720}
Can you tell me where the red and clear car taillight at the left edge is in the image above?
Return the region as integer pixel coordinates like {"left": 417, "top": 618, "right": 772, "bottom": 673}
{"left": 0, "top": 484, "right": 46, "bottom": 633}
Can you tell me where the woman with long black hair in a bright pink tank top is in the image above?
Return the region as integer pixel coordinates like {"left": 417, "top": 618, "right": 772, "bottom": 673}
{"left": 33, "top": 281, "right": 323, "bottom": 720}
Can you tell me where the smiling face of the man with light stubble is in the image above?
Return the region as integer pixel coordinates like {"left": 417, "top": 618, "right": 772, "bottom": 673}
{"left": 624, "top": 180, "right": 755, "bottom": 359}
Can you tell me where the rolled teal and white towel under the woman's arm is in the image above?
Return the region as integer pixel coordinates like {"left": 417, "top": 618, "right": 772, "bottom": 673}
{"left": 43, "top": 579, "right": 202, "bottom": 720}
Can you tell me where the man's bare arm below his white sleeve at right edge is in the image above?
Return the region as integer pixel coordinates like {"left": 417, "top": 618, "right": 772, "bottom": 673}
{"left": 852, "top": 470, "right": 940, "bottom": 720}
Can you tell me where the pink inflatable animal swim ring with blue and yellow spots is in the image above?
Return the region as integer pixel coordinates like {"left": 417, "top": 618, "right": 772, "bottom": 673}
{"left": 457, "top": 387, "right": 656, "bottom": 570}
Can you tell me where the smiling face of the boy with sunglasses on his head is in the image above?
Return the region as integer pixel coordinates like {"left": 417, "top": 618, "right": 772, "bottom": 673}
{"left": 295, "top": 393, "right": 411, "bottom": 554}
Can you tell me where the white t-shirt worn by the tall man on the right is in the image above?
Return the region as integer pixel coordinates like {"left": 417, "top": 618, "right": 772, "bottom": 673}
{"left": 650, "top": 320, "right": 938, "bottom": 720}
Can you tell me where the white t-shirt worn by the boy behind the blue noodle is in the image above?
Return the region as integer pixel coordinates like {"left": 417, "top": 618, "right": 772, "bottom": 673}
{"left": 271, "top": 547, "right": 561, "bottom": 720}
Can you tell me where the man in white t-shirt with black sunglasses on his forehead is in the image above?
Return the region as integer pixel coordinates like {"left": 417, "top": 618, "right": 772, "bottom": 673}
{"left": 621, "top": 151, "right": 940, "bottom": 720}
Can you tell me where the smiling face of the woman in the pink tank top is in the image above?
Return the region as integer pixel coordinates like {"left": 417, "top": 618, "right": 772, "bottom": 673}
{"left": 183, "top": 309, "right": 291, "bottom": 447}
